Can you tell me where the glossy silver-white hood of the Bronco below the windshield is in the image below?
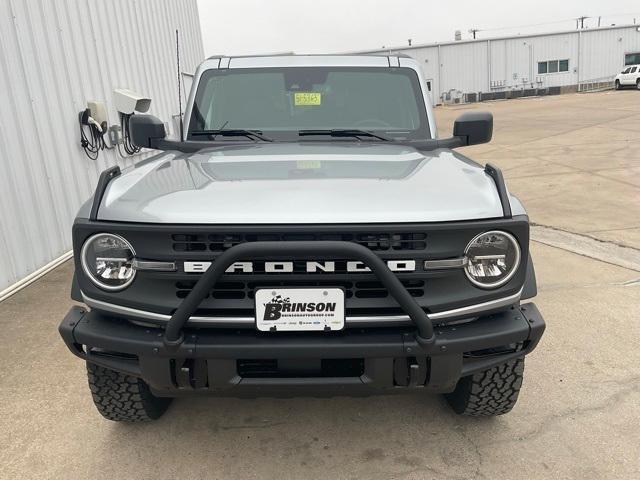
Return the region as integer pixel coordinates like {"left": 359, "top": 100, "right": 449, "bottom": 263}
{"left": 98, "top": 142, "right": 502, "bottom": 224}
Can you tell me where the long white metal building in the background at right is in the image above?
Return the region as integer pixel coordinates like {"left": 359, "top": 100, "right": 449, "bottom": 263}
{"left": 366, "top": 25, "right": 640, "bottom": 103}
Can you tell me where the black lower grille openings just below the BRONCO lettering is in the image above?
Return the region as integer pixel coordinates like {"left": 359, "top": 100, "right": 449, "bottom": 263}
{"left": 175, "top": 279, "right": 425, "bottom": 300}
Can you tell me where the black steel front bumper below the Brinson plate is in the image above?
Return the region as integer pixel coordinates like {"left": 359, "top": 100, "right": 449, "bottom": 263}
{"left": 59, "top": 303, "right": 545, "bottom": 396}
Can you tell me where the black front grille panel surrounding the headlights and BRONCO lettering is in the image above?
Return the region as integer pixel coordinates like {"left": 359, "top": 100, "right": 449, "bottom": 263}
{"left": 73, "top": 216, "right": 529, "bottom": 317}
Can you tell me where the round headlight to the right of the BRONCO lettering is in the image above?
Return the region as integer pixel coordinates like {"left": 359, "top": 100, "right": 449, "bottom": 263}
{"left": 464, "top": 231, "right": 520, "bottom": 288}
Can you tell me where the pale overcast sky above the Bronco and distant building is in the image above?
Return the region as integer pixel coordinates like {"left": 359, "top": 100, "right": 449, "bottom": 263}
{"left": 198, "top": 0, "right": 640, "bottom": 56}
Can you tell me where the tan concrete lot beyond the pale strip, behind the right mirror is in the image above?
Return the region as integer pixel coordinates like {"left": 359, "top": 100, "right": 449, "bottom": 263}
{"left": 436, "top": 90, "right": 640, "bottom": 248}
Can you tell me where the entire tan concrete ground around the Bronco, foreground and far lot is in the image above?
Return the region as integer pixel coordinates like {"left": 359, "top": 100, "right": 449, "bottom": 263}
{"left": 0, "top": 91, "right": 640, "bottom": 479}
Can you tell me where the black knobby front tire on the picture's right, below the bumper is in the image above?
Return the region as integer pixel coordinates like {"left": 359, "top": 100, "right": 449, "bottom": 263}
{"left": 445, "top": 358, "right": 524, "bottom": 417}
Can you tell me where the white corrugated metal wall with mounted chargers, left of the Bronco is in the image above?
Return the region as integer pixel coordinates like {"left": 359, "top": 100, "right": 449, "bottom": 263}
{"left": 0, "top": 0, "right": 204, "bottom": 291}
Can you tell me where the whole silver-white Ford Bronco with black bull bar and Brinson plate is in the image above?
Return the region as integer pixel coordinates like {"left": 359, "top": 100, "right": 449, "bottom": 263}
{"left": 59, "top": 55, "right": 545, "bottom": 422}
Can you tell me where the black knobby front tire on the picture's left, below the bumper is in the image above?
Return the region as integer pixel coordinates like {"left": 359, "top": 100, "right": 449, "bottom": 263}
{"left": 87, "top": 363, "right": 171, "bottom": 422}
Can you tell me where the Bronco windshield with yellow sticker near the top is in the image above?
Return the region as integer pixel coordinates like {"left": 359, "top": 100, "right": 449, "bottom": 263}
{"left": 188, "top": 67, "right": 430, "bottom": 141}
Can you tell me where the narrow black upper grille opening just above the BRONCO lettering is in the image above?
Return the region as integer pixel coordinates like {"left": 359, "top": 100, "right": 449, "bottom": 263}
{"left": 171, "top": 232, "right": 427, "bottom": 252}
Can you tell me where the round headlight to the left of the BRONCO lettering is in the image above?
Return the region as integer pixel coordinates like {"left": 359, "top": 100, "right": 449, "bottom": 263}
{"left": 80, "top": 233, "right": 136, "bottom": 291}
